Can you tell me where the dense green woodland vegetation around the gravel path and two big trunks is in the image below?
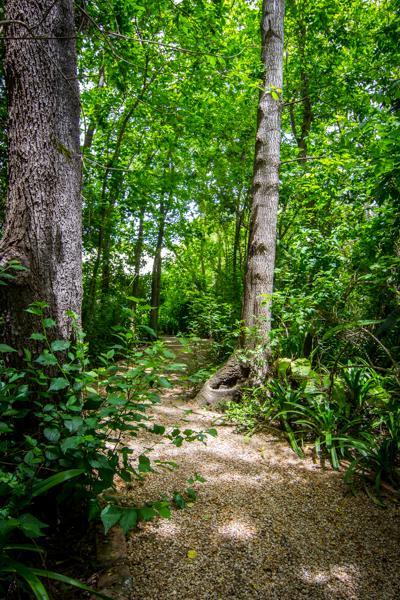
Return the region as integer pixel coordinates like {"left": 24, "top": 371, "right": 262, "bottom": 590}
{"left": 0, "top": 0, "right": 400, "bottom": 598}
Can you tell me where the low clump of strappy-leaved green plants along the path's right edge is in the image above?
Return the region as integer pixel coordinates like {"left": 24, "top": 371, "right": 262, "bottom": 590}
{"left": 228, "top": 359, "right": 400, "bottom": 503}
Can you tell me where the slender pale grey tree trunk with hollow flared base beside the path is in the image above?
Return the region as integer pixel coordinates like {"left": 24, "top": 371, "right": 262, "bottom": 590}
{"left": 198, "top": 0, "right": 285, "bottom": 404}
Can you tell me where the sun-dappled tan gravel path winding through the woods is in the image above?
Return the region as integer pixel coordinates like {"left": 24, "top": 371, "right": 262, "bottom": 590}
{"left": 119, "top": 338, "right": 400, "bottom": 600}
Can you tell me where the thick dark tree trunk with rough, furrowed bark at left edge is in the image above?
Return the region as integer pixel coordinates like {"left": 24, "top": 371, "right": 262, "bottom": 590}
{"left": 0, "top": 0, "right": 82, "bottom": 350}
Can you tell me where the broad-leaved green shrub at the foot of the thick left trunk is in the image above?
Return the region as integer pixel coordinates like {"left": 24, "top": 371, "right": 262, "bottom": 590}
{"left": 0, "top": 303, "right": 211, "bottom": 598}
